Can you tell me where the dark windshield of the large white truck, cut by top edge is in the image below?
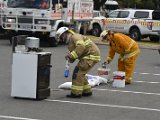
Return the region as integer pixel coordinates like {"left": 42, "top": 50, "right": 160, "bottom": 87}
{"left": 7, "top": 0, "right": 50, "bottom": 9}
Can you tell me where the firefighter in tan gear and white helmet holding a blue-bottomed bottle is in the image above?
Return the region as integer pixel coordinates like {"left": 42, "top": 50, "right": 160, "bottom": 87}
{"left": 56, "top": 27, "right": 100, "bottom": 98}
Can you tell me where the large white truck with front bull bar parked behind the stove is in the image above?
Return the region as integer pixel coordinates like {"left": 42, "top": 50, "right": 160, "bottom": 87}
{"left": 2, "top": 0, "right": 93, "bottom": 46}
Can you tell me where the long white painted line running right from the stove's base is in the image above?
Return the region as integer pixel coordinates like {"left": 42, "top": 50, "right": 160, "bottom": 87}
{"left": 45, "top": 99, "right": 160, "bottom": 112}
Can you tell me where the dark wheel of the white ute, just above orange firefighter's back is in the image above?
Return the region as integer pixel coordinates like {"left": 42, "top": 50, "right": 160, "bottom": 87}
{"left": 130, "top": 28, "right": 141, "bottom": 41}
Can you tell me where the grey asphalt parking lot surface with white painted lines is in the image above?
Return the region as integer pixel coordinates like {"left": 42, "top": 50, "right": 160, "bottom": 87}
{"left": 0, "top": 40, "right": 160, "bottom": 120}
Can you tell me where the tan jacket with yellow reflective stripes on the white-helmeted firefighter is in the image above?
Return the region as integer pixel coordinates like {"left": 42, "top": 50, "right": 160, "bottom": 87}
{"left": 68, "top": 33, "right": 100, "bottom": 62}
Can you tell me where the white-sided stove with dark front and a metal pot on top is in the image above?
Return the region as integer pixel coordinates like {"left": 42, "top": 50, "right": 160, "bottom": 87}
{"left": 11, "top": 35, "right": 51, "bottom": 100}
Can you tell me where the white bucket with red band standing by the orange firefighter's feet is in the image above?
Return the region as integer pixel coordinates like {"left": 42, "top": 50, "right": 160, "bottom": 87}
{"left": 112, "top": 71, "right": 125, "bottom": 88}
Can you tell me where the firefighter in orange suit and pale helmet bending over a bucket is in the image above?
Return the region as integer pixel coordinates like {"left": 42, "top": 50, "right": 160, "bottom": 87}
{"left": 100, "top": 30, "right": 140, "bottom": 85}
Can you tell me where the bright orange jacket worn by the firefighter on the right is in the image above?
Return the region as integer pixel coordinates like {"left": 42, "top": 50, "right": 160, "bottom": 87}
{"left": 108, "top": 33, "right": 140, "bottom": 60}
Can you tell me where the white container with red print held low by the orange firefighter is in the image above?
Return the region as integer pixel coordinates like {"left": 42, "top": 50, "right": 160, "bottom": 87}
{"left": 97, "top": 68, "right": 111, "bottom": 79}
